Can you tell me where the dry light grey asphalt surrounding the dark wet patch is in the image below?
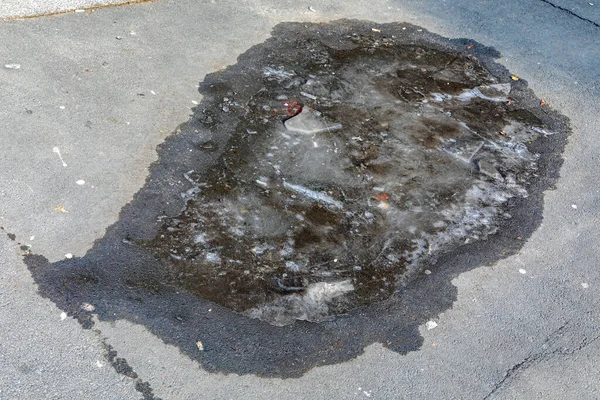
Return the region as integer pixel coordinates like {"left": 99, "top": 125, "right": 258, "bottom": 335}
{"left": 0, "top": 0, "right": 600, "bottom": 399}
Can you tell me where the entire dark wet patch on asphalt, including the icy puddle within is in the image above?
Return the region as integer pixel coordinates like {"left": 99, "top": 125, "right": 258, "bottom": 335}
{"left": 25, "top": 20, "right": 568, "bottom": 377}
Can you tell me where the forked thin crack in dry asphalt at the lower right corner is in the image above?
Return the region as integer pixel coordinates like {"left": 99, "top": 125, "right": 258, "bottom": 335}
{"left": 483, "top": 321, "right": 600, "bottom": 400}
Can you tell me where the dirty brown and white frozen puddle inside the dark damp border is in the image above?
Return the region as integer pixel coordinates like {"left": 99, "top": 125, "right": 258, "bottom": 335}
{"left": 146, "top": 25, "right": 545, "bottom": 325}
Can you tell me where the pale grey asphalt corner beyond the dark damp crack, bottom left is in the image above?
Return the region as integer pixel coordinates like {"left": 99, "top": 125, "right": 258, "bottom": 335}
{"left": 0, "top": 240, "right": 136, "bottom": 400}
